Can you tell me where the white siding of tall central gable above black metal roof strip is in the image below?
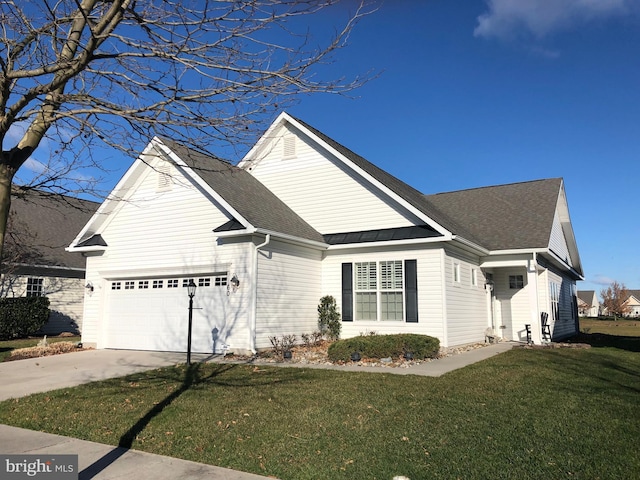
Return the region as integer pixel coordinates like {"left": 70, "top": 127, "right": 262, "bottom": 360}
{"left": 248, "top": 124, "right": 419, "bottom": 234}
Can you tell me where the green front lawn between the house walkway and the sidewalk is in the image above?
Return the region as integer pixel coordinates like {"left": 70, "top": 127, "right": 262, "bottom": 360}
{"left": 0, "top": 336, "right": 640, "bottom": 480}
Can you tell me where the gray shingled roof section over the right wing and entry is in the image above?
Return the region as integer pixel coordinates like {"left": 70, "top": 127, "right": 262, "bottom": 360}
{"left": 426, "top": 178, "right": 562, "bottom": 250}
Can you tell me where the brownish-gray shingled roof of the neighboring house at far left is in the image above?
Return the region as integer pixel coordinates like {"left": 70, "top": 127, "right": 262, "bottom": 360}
{"left": 5, "top": 190, "right": 100, "bottom": 270}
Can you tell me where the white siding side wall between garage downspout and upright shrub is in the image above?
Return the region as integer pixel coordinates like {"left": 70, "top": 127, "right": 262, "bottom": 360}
{"left": 256, "top": 240, "right": 323, "bottom": 349}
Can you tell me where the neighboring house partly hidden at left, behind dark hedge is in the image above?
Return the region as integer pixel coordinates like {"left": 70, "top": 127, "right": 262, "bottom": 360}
{"left": 0, "top": 188, "right": 99, "bottom": 335}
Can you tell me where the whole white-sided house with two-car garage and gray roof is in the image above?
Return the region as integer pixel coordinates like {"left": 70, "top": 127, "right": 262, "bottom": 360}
{"left": 68, "top": 113, "right": 582, "bottom": 352}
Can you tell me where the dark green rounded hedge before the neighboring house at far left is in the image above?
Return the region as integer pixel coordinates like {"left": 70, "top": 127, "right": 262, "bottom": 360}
{"left": 0, "top": 297, "right": 49, "bottom": 340}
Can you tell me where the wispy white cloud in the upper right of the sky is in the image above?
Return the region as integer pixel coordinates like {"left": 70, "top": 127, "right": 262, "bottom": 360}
{"left": 474, "top": 0, "right": 640, "bottom": 39}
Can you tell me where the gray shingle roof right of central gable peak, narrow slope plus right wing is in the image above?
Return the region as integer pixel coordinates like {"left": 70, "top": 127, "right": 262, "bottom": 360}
{"left": 293, "top": 117, "right": 561, "bottom": 250}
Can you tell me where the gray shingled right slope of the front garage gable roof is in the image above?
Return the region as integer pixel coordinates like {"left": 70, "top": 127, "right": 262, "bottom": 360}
{"left": 161, "top": 138, "right": 324, "bottom": 243}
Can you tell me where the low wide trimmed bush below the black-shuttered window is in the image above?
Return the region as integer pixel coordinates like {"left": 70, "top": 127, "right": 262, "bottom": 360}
{"left": 327, "top": 333, "right": 440, "bottom": 362}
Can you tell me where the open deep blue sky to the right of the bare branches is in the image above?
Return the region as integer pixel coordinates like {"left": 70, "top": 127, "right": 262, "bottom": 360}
{"left": 289, "top": 0, "right": 640, "bottom": 292}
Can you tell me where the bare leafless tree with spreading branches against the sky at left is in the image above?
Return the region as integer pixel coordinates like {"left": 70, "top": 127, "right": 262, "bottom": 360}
{"left": 0, "top": 0, "right": 373, "bottom": 266}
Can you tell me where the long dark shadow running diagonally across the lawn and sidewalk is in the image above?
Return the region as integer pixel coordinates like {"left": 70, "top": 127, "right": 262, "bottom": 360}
{"left": 78, "top": 363, "right": 272, "bottom": 480}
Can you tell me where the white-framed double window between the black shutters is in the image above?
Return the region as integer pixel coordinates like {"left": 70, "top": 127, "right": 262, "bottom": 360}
{"left": 353, "top": 260, "right": 406, "bottom": 322}
